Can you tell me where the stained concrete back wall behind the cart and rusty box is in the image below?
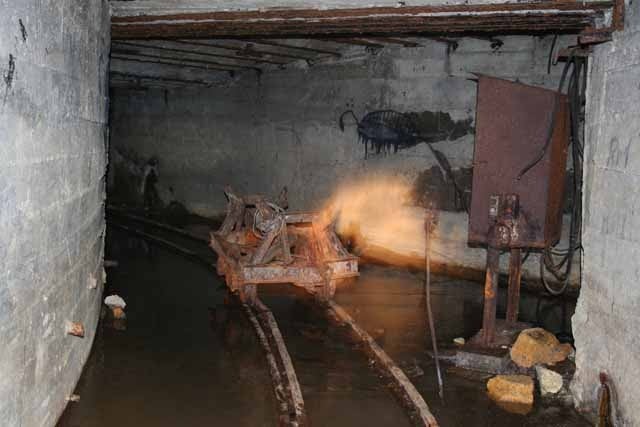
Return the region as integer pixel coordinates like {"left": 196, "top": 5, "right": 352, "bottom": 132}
{"left": 111, "top": 37, "right": 579, "bottom": 283}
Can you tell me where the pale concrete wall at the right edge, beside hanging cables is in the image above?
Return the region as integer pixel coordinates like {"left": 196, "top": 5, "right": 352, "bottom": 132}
{"left": 572, "top": 2, "right": 640, "bottom": 426}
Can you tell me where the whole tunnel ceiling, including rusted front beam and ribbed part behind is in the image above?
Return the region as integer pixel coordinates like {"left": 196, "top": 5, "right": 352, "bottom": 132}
{"left": 111, "top": 0, "right": 623, "bottom": 86}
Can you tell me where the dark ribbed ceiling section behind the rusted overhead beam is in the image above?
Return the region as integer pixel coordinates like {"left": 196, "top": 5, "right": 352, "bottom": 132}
{"left": 111, "top": 37, "right": 430, "bottom": 87}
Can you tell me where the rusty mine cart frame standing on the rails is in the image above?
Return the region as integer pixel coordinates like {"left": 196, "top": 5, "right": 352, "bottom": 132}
{"left": 209, "top": 187, "right": 359, "bottom": 303}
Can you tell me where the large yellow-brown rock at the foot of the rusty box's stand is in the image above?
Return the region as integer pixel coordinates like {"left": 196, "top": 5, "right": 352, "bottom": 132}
{"left": 510, "top": 328, "right": 573, "bottom": 368}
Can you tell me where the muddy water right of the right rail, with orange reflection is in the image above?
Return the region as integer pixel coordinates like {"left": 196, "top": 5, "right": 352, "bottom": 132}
{"left": 336, "top": 266, "right": 590, "bottom": 427}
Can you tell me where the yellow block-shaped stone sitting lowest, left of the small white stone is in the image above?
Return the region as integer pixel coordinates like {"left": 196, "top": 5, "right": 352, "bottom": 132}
{"left": 487, "top": 375, "right": 533, "bottom": 415}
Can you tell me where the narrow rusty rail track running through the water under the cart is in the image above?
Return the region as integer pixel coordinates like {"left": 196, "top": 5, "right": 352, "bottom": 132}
{"left": 107, "top": 207, "right": 438, "bottom": 427}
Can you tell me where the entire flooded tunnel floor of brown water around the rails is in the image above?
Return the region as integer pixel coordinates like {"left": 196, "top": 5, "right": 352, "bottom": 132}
{"left": 58, "top": 229, "right": 589, "bottom": 427}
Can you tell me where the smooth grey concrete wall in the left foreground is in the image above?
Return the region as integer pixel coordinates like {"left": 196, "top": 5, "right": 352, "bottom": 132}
{"left": 0, "top": 0, "right": 110, "bottom": 427}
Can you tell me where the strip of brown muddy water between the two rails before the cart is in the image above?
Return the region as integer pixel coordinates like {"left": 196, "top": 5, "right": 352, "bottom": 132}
{"left": 260, "top": 285, "right": 411, "bottom": 427}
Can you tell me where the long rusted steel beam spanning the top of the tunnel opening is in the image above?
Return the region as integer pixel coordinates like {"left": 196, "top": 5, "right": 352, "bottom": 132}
{"left": 111, "top": 0, "right": 613, "bottom": 40}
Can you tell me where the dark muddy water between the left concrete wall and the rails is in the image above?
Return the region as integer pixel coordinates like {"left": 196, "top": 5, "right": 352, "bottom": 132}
{"left": 58, "top": 231, "right": 276, "bottom": 427}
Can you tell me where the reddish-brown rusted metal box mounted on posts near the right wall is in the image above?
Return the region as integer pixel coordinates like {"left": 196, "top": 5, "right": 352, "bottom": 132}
{"left": 469, "top": 76, "right": 569, "bottom": 248}
